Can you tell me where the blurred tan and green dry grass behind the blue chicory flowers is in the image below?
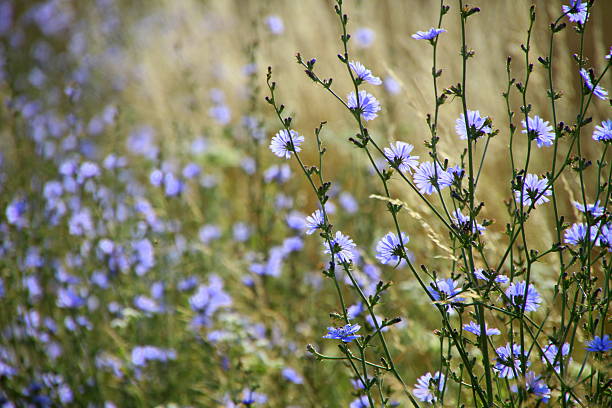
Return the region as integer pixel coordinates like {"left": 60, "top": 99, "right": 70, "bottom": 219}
{"left": 0, "top": 0, "right": 612, "bottom": 407}
